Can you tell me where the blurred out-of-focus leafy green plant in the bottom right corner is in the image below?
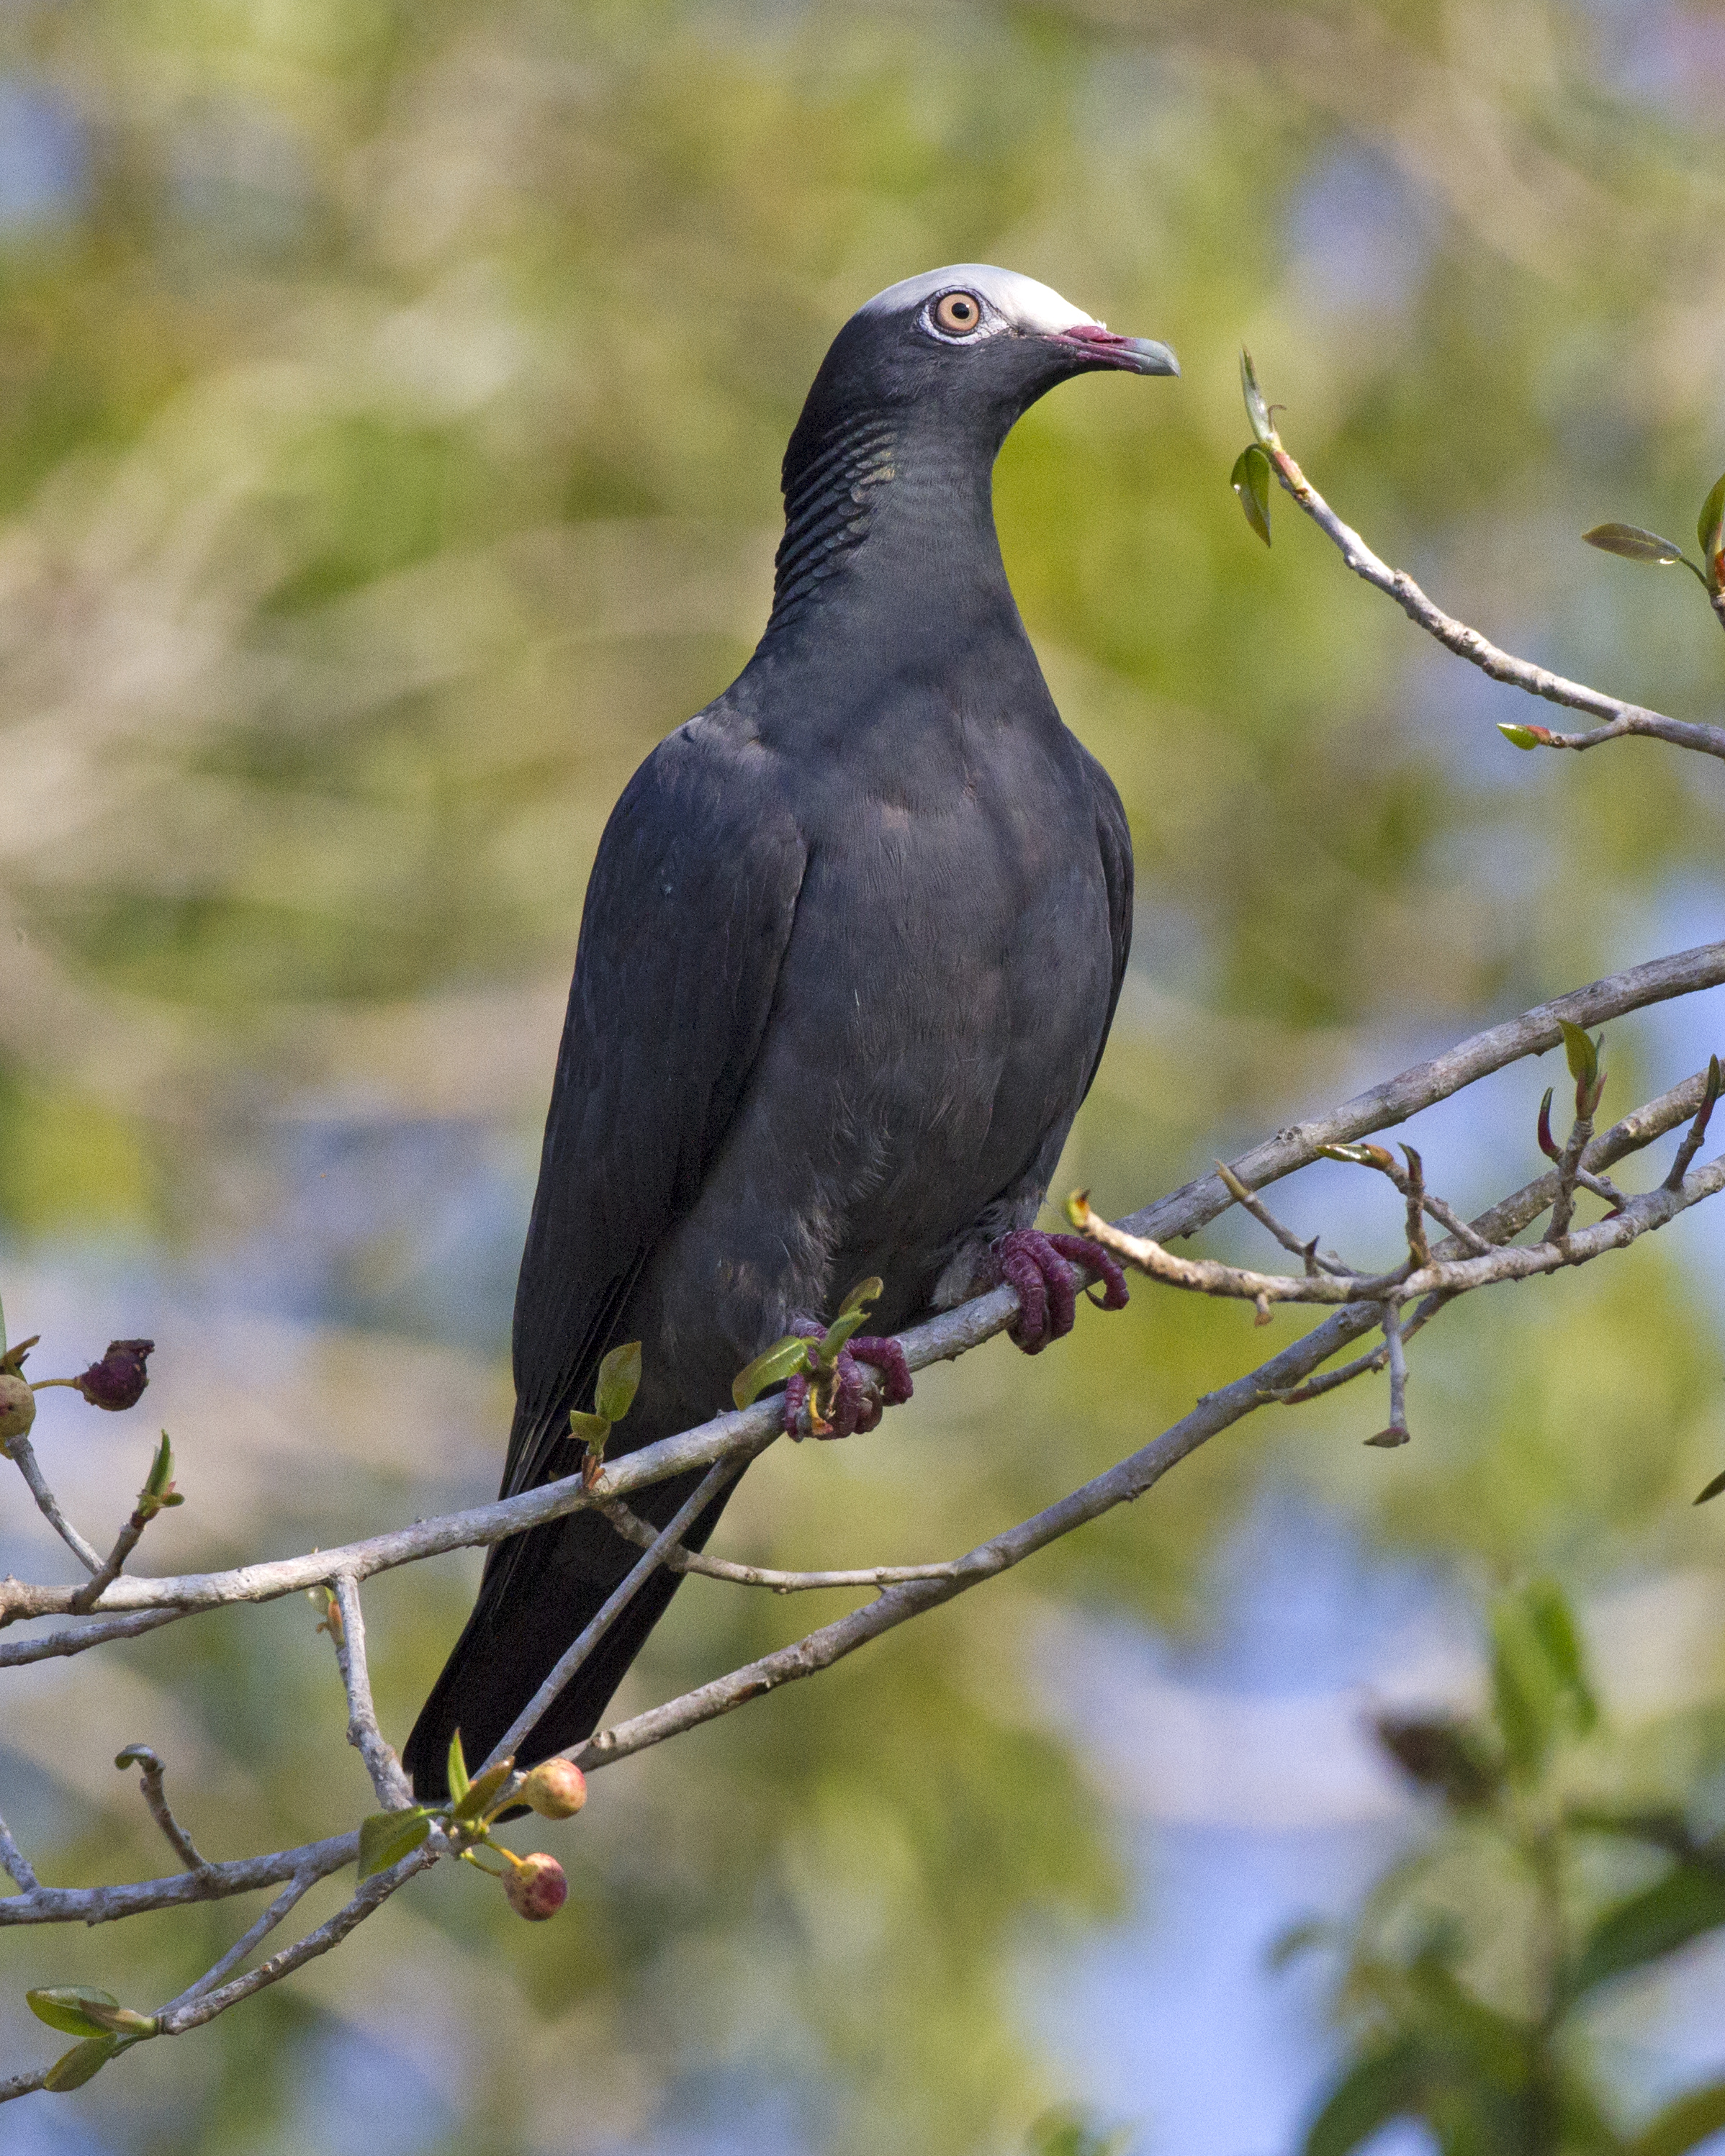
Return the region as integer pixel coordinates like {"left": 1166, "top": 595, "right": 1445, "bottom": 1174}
{"left": 1287, "top": 1580, "right": 1725, "bottom": 2156}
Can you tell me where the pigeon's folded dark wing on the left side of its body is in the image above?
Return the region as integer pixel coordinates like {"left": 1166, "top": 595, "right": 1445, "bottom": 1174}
{"left": 503, "top": 720, "right": 806, "bottom": 1497}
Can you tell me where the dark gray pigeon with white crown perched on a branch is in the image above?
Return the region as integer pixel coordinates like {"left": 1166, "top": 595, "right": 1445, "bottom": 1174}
{"left": 407, "top": 265, "right": 1177, "bottom": 1796}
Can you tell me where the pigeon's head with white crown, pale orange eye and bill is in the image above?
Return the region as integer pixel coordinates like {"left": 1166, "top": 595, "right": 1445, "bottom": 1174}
{"left": 798, "top": 263, "right": 1179, "bottom": 469}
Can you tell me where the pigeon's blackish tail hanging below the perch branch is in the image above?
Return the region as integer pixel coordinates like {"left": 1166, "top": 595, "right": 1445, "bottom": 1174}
{"left": 401, "top": 1473, "right": 735, "bottom": 1803}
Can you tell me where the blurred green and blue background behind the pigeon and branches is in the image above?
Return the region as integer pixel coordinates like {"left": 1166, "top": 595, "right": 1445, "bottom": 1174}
{"left": 0, "top": 0, "right": 1725, "bottom": 2156}
